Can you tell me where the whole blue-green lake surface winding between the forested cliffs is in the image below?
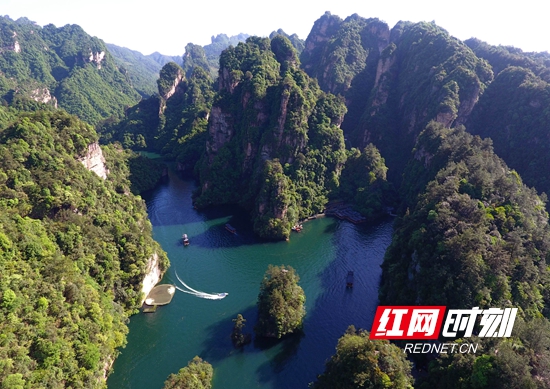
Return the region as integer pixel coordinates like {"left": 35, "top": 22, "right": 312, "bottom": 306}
{"left": 108, "top": 173, "right": 392, "bottom": 389}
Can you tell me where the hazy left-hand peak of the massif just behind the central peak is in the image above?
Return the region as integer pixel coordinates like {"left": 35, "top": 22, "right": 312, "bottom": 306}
{"left": 301, "top": 13, "right": 394, "bottom": 151}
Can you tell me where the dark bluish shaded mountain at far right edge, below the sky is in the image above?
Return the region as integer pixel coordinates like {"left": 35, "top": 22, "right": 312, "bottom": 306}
{"left": 467, "top": 41, "right": 550, "bottom": 202}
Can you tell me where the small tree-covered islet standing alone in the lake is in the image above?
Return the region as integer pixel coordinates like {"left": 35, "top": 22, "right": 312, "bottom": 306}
{"left": 254, "top": 265, "right": 306, "bottom": 338}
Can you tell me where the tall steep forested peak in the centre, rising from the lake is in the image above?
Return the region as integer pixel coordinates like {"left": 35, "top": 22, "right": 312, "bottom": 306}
{"left": 196, "top": 35, "right": 345, "bottom": 239}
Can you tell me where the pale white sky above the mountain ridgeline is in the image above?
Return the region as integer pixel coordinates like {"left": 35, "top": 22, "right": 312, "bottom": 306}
{"left": 0, "top": 0, "right": 550, "bottom": 55}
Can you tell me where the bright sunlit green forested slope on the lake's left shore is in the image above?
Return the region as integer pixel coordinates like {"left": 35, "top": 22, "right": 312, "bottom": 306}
{"left": 0, "top": 104, "right": 168, "bottom": 388}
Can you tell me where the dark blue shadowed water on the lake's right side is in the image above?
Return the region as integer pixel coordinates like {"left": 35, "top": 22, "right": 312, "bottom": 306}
{"left": 253, "top": 219, "right": 393, "bottom": 389}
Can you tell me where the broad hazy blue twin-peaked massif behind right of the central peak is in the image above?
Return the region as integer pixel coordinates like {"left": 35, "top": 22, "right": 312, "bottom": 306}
{"left": 302, "top": 14, "right": 493, "bottom": 181}
